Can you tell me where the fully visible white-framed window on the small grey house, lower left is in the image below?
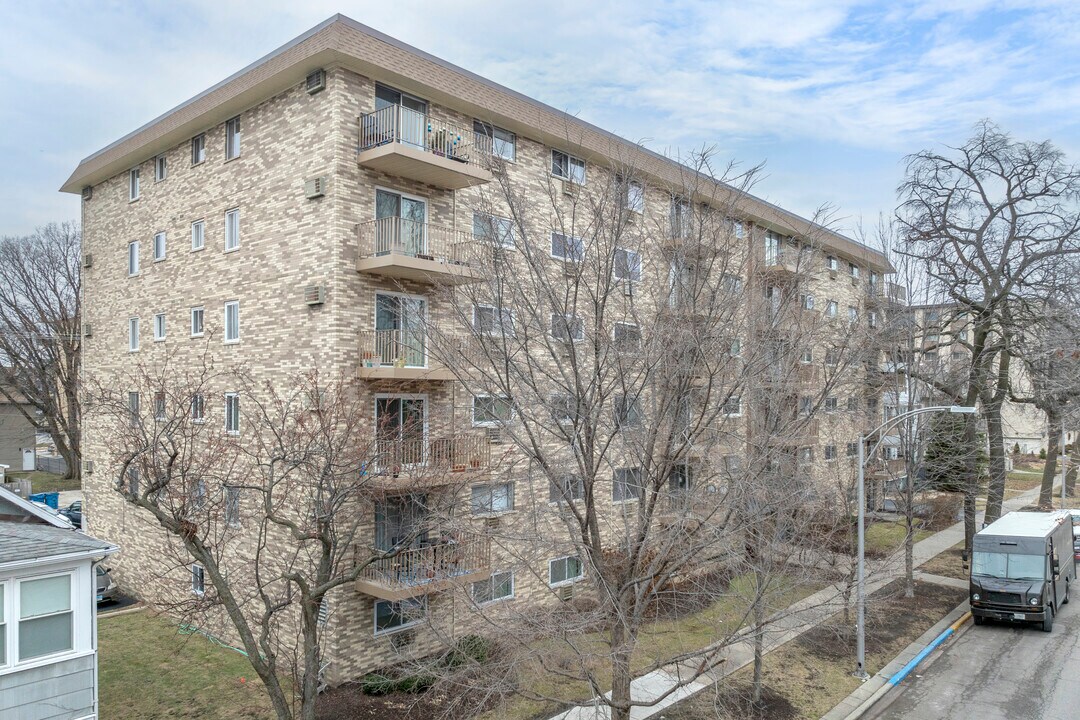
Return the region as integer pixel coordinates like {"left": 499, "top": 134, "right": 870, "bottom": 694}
{"left": 17, "top": 574, "right": 75, "bottom": 662}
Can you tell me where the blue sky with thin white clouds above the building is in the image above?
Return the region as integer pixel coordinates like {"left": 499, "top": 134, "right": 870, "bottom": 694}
{"left": 0, "top": 0, "right": 1080, "bottom": 241}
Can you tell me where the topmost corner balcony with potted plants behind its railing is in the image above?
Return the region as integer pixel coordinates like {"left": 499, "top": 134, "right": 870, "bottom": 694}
{"left": 356, "top": 105, "right": 492, "bottom": 190}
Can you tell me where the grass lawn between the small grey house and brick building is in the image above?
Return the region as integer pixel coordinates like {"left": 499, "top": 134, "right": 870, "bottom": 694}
{"left": 97, "top": 611, "right": 272, "bottom": 720}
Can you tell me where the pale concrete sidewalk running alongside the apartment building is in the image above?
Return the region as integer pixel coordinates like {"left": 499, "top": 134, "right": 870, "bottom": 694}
{"left": 551, "top": 488, "right": 1039, "bottom": 720}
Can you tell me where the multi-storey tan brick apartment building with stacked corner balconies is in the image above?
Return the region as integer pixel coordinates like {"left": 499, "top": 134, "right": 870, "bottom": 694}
{"left": 63, "top": 16, "right": 892, "bottom": 681}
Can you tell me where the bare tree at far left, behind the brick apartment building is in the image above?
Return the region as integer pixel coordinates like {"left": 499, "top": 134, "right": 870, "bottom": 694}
{"left": 0, "top": 222, "right": 82, "bottom": 477}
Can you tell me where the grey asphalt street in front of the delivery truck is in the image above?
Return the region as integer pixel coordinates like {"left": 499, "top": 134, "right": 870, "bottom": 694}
{"left": 866, "top": 594, "right": 1080, "bottom": 720}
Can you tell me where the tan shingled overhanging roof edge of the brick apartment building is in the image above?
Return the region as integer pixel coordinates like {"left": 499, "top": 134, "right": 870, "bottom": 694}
{"left": 60, "top": 15, "right": 892, "bottom": 272}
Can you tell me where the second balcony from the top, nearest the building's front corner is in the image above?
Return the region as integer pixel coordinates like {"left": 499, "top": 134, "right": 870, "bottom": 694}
{"left": 356, "top": 217, "right": 483, "bottom": 285}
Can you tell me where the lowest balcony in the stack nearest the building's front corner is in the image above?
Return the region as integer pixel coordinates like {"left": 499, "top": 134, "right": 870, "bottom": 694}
{"left": 355, "top": 532, "right": 491, "bottom": 600}
